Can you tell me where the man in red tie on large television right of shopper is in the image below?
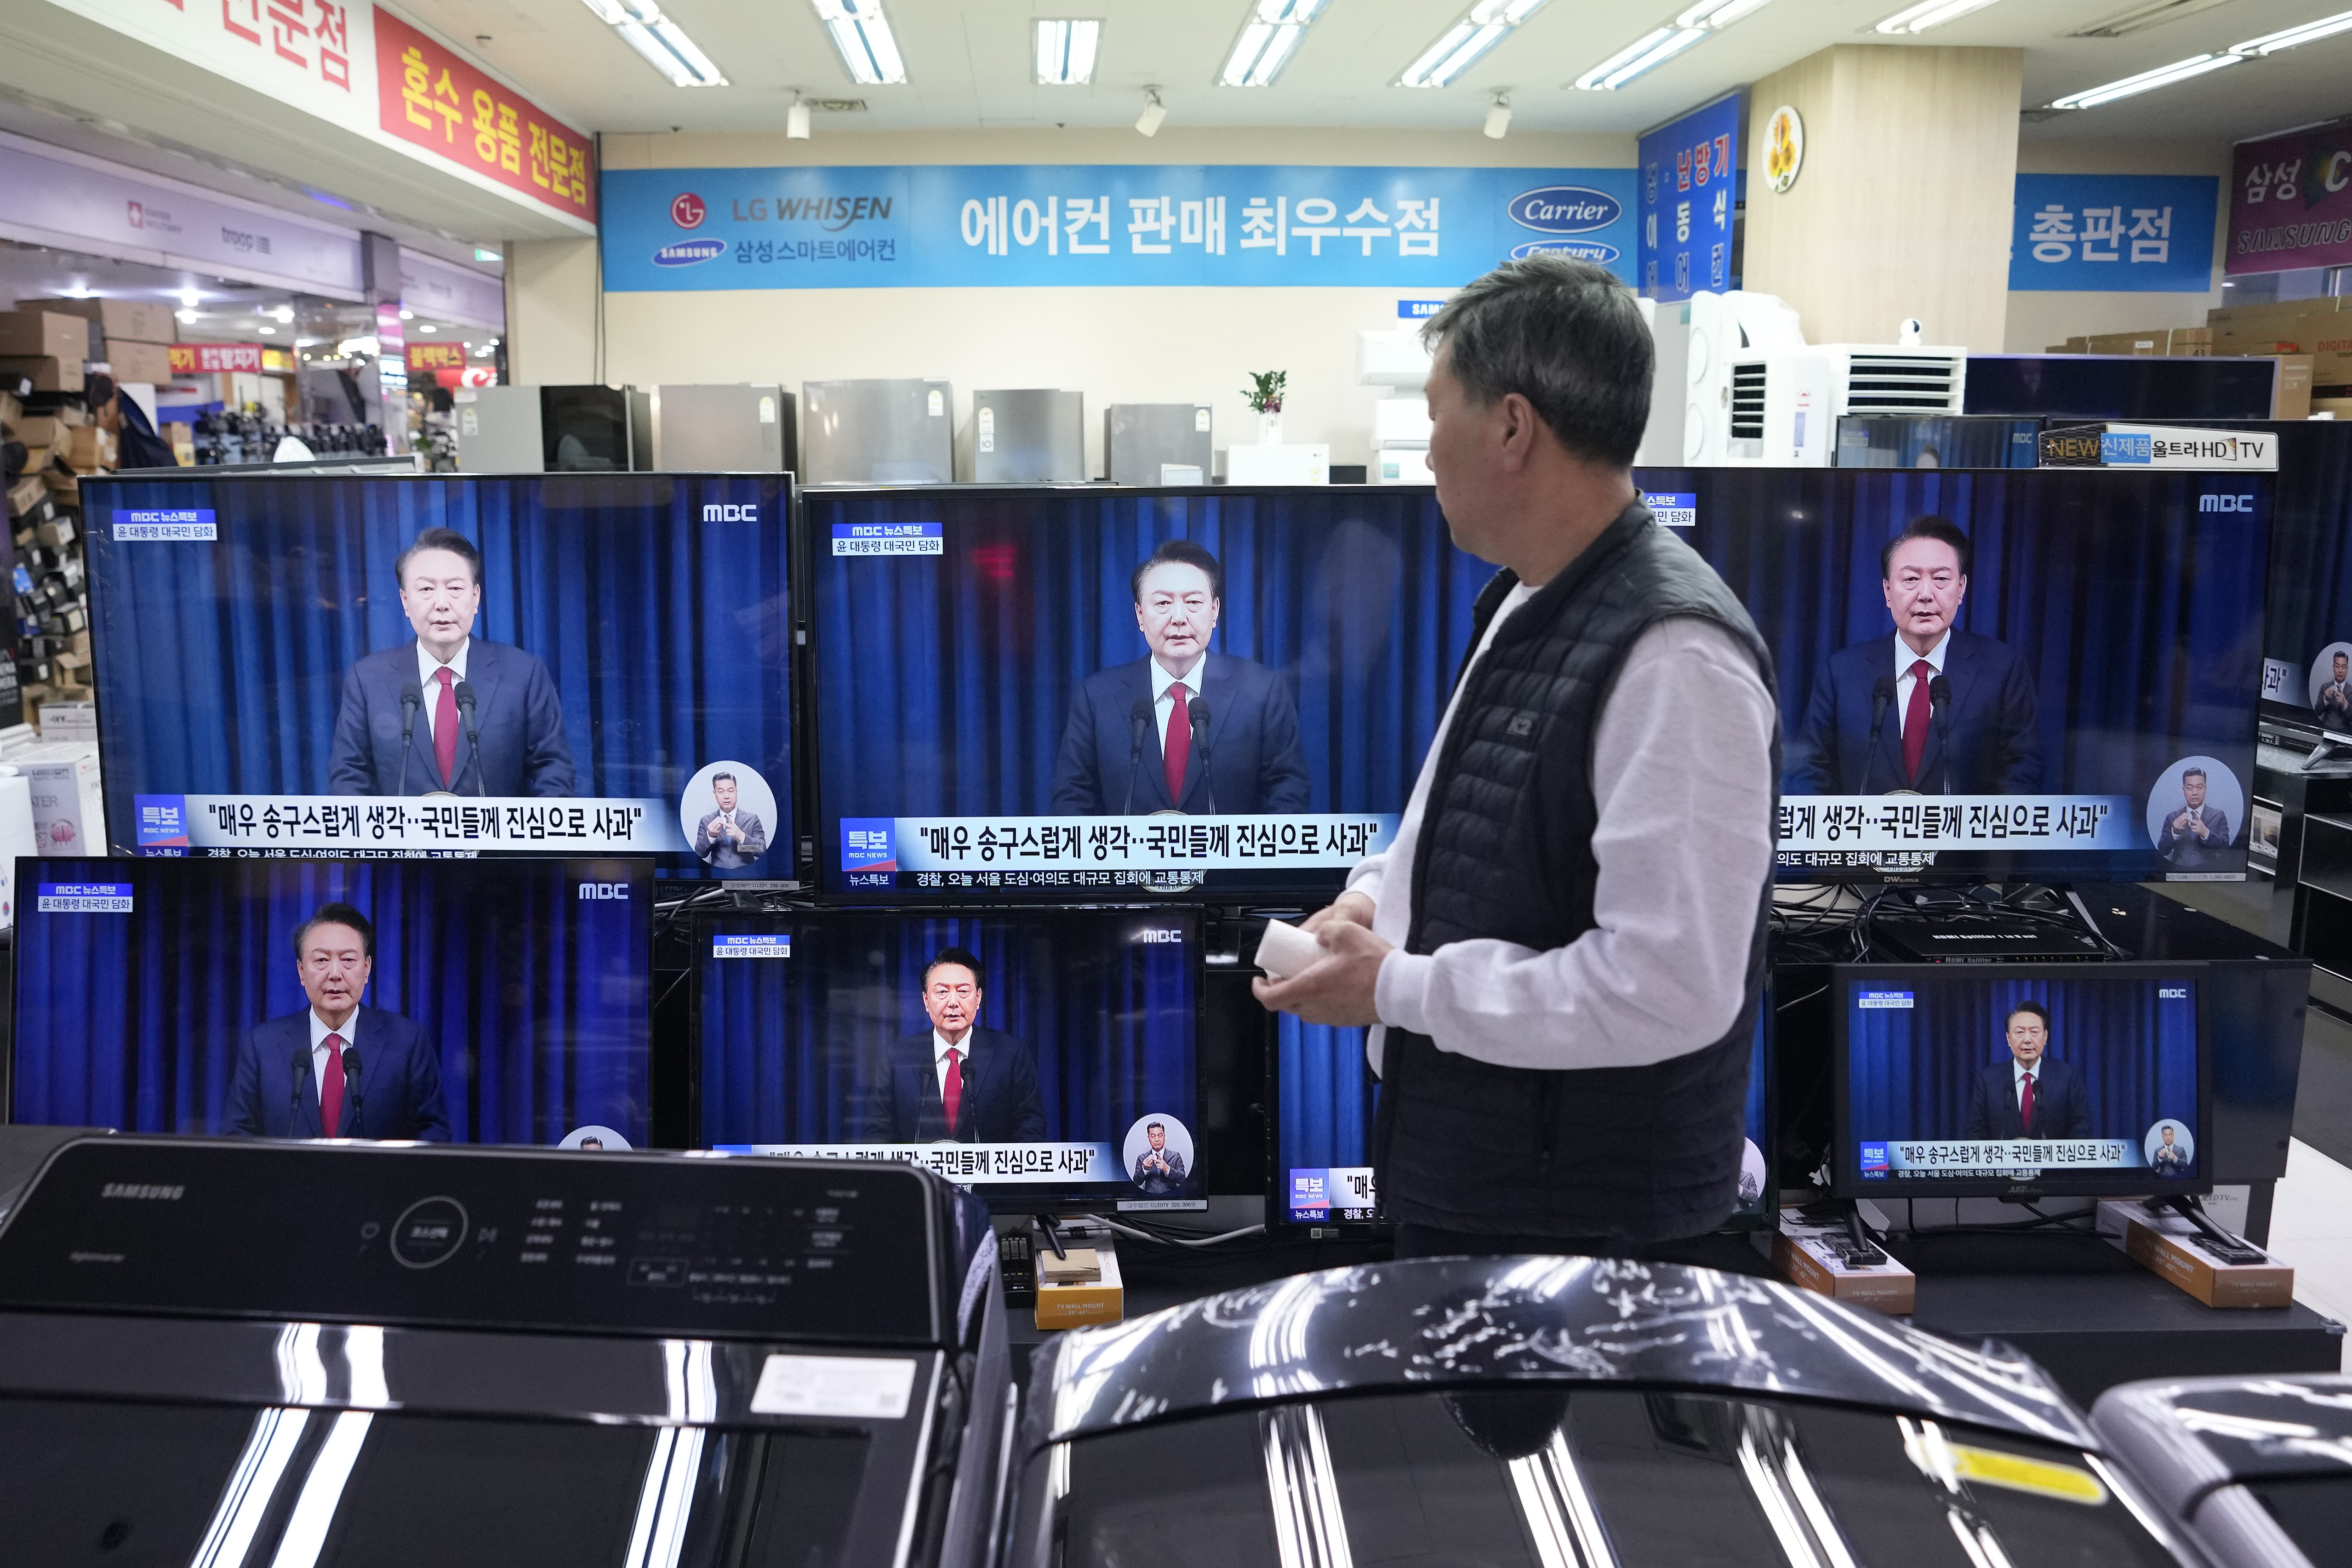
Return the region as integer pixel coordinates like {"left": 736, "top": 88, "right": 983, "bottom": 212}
{"left": 1781, "top": 517, "right": 2042, "bottom": 795}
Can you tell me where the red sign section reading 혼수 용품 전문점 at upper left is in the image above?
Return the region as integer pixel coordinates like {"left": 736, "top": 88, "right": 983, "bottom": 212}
{"left": 377, "top": 7, "right": 595, "bottom": 223}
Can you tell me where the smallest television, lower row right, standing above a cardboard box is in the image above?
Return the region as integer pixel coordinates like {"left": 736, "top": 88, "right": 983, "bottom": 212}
{"left": 1832, "top": 964, "right": 2211, "bottom": 1199}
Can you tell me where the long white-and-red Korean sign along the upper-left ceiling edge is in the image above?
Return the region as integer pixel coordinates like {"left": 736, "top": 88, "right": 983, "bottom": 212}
{"left": 49, "top": 0, "right": 595, "bottom": 233}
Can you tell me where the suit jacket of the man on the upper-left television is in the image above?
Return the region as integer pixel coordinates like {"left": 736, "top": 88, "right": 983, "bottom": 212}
{"left": 327, "top": 637, "right": 571, "bottom": 799}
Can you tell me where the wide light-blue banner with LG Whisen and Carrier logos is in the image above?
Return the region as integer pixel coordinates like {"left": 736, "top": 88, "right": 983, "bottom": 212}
{"left": 602, "top": 165, "right": 1635, "bottom": 291}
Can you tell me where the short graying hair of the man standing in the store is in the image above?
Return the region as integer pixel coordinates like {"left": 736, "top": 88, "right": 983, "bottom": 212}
{"left": 1421, "top": 251, "right": 1656, "bottom": 468}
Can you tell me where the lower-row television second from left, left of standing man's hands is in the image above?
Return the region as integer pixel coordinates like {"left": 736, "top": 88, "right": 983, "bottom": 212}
{"left": 694, "top": 907, "right": 1194, "bottom": 1211}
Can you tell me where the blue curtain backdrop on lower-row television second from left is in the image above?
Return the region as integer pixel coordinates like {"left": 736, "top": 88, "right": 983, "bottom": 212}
{"left": 698, "top": 914, "right": 1199, "bottom": 1145}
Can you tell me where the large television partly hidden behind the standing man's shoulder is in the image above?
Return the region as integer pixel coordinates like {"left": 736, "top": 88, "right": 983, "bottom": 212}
{"left": 1637, "top": 468, "right": 2272, "bottom": 882}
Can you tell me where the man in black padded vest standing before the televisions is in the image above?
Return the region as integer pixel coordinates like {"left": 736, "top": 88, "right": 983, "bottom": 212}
{"left": 1256, "top": 254, "right": 1781, "bottom": 1262}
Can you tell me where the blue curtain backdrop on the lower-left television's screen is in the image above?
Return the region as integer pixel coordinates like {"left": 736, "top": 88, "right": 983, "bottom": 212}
{"left": 14, "top": 861, "right": 651, "bottom": 1145}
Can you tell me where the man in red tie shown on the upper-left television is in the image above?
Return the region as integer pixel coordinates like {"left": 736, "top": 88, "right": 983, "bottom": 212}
{"left": 327, "top": 529, "right": 571, "bottom": 799}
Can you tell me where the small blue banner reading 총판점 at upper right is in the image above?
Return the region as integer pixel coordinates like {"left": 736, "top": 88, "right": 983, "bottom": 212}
{"left": 2009, "top": 174, "right": 2221, "bottom": 294}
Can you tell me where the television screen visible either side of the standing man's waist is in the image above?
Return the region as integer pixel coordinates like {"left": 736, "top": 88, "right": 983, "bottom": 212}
{"left": 1265, "top": 1006, "right": 1778, "bottom": 1230}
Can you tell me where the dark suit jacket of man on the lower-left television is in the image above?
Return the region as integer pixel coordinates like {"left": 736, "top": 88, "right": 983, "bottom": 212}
{"left": 221, "top": 1006, "right": 449, "bottom": 1142}
